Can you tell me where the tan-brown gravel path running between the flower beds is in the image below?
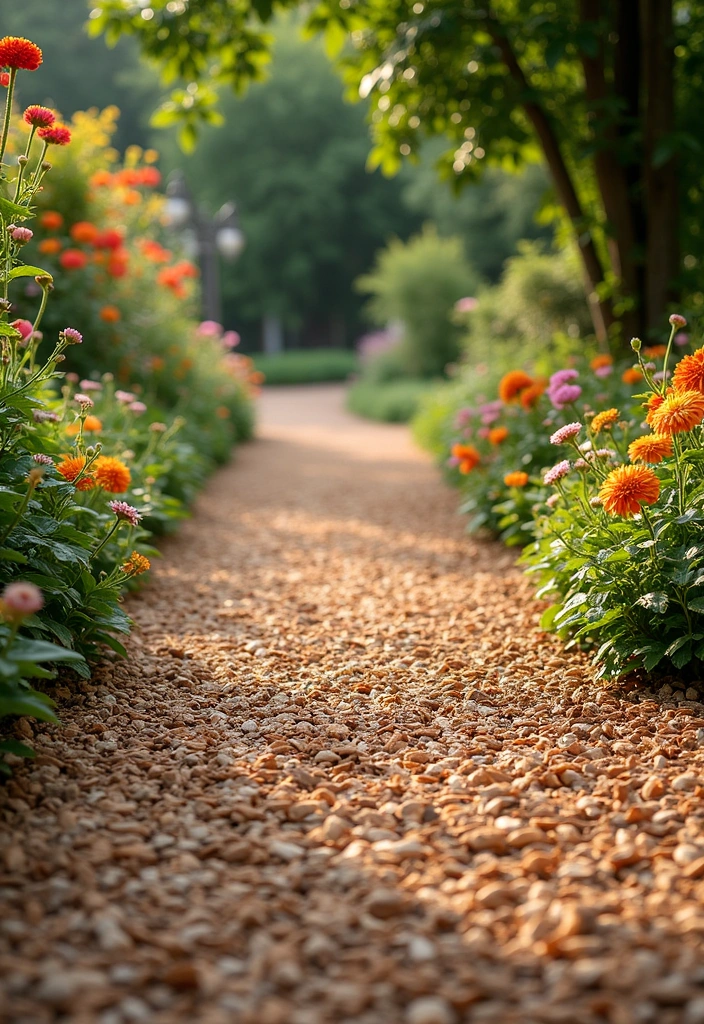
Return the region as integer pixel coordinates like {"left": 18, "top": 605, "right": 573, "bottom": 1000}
{"left": 0, "top": 387, "right": 704, "bottom": 1024}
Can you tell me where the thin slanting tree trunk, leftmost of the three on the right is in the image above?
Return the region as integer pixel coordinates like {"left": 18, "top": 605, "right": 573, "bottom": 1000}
{"left": 489, "top": 16, "right": 616, "bottom": 343}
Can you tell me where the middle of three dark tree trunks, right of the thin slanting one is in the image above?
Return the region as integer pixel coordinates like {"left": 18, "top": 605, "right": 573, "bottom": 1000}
{"left": 579, "top": 0, "right": 644, "bottom": 342}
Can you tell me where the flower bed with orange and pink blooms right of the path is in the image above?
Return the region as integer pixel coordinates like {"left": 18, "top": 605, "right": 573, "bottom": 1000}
{"left": 417, "top": 314, "right": 704, "bottom": 679}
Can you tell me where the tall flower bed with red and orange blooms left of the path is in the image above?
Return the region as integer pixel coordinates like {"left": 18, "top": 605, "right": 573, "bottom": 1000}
{"left": 0, "top": 37, "right": 251, "bottom": 770}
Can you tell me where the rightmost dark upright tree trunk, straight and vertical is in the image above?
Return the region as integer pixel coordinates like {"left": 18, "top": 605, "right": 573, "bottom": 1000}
{"left": 641, "top": 0, "right": 679, "bottom": 332}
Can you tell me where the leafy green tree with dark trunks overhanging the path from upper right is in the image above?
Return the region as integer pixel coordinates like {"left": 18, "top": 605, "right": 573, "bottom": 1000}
{"left": 92, "top": 0, "right": 704, "bottom": 348}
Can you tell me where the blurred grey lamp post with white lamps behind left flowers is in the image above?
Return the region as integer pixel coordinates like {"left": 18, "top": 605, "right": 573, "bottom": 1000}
{"left": 166, "top": 171, "right": 245, "bottom": 324}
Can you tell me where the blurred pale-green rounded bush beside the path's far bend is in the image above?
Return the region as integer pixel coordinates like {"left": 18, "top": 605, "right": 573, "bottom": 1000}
{"left": 357, "top": 225, "right": 477, "bottom": 377}
